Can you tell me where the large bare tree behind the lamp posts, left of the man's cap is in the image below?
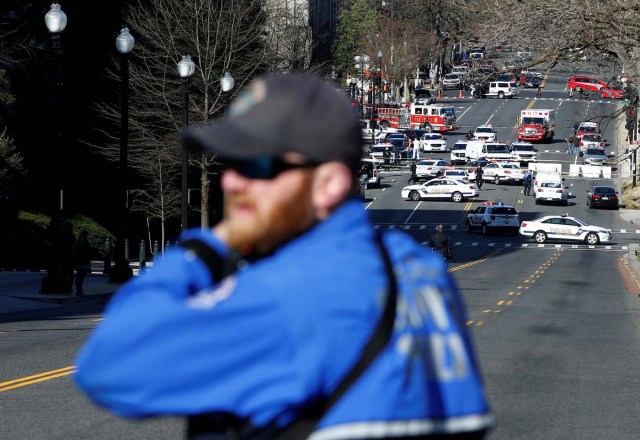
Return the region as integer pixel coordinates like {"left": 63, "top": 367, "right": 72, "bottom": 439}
{"left": 89, "top": 0, "right": 265, "bottom": 248}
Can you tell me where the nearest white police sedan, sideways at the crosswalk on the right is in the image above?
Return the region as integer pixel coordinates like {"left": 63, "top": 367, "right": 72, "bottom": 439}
{"left": 520, "top": 214, "right": 612, "bottom": 245}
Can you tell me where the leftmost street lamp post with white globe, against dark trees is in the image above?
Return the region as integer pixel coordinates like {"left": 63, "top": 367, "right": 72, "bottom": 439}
{"left": 44, "top": 2, "right": 67, "bottom": 211}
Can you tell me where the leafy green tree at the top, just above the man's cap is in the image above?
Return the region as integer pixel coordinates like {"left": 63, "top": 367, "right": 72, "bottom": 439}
{"left": 333, "top": 0, "right": 380, "bottom": 71}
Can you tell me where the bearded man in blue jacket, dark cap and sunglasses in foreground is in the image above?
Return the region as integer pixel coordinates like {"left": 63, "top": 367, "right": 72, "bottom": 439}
{"left": 74, "top": 74, "right": 493, "bottom": 440}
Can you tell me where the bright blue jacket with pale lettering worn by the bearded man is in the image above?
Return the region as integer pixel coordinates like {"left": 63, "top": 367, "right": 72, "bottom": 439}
{"left": 74, "top": 201, "right": 493, "bottom": 440}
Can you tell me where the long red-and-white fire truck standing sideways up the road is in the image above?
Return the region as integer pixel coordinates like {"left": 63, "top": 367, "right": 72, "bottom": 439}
{"left": 365, "top": 103, "right": 460, "bottom": 132}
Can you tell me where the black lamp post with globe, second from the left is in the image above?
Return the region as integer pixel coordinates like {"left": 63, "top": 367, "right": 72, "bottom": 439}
{"left": 108, "top": 27, "right": 135, "bottom": 282}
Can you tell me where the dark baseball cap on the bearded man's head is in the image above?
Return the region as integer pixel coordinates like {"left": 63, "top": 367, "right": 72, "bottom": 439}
{"left": 182, "top": 73, "right": 362, "bottom": 171}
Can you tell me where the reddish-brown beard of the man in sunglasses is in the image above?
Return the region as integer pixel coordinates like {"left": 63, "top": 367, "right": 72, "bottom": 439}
{"left": 224, "top": 185, "right": 316, "bottom": 255}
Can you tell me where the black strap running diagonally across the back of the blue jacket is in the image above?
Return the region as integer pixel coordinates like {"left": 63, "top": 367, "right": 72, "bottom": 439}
{"left": 275, "top": 233, "right": 398, "bottom": 440}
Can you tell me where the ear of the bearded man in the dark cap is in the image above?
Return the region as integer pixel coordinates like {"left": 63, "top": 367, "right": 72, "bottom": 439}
{"left": 311, "top": 162, "right": 354, "bottom": 218}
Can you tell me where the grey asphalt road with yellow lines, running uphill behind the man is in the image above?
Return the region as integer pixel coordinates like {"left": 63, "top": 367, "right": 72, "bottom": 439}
{"left": 0, "top": 65, "right": 640, "bottom": 440}
